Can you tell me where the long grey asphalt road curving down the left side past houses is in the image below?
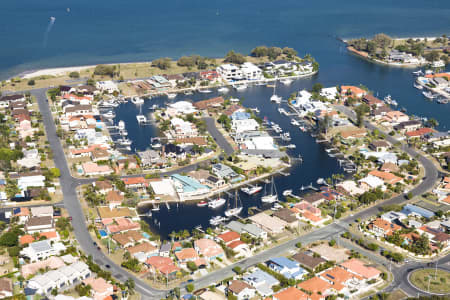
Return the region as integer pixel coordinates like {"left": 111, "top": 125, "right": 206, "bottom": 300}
{"left": 31, "top": 89, "right": 166, "bottom": 299}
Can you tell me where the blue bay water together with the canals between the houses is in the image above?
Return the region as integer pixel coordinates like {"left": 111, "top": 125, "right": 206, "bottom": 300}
{"left": 0, "top": 0, "right": 450, "bottom": 236}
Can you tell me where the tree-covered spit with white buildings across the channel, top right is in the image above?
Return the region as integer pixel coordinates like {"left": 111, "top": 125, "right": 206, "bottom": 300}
{"left": 344, "top": 33, "right": 450, "bottom": 68}
